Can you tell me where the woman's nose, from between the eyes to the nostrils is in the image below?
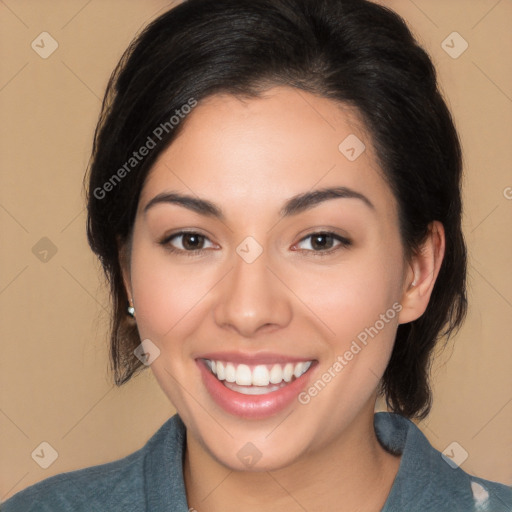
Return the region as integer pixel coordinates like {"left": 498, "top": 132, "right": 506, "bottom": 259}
{"left": 214, "top": 246, "right": 292, "bottom": 338}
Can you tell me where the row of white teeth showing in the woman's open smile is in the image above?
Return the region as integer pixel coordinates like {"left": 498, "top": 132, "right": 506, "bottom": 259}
{"left": 202, "top": 359, "right": 314, "bottom": 395}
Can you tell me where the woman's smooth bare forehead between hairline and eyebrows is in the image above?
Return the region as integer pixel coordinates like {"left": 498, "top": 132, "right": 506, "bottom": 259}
{"left": 140, "top": 87, "right": 395, "bottom": 222}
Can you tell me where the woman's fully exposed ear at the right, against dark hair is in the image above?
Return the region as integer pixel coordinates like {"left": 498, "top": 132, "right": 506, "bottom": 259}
{"left": 399, "top": 221, "right": 445, "bottom": 324}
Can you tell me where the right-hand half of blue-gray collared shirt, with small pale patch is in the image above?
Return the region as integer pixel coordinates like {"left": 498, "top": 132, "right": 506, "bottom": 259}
{"left": 374, "top": 413, "right": 512, "bottom": 512}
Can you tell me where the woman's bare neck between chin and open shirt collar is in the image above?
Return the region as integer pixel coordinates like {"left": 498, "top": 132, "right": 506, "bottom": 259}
{"left": 184, "top": 405, "right": 400, "bottom": 512}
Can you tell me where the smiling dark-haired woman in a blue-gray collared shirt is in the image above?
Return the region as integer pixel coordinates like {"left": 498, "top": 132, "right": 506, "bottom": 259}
{"left": 3, "top": 0, "right": 512, "bottom": 512}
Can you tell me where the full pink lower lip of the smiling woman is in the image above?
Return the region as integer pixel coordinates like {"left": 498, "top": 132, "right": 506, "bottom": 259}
{"left": 196, "top": 360, "right": 314, "bottom": 419}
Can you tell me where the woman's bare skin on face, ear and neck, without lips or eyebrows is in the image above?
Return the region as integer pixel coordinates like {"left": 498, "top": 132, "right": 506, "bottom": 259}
{"left": 120, "top": 87, "right": 444, "bottom": 512}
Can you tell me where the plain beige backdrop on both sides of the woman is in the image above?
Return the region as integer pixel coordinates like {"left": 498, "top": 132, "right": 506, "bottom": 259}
{"left": 0, "top": 0, "right": 512, "bottom": 499}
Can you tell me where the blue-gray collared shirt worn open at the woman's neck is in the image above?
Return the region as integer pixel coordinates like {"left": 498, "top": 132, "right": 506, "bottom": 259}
{"left": 0, "top": 412, "right": 512, "bottom": 512}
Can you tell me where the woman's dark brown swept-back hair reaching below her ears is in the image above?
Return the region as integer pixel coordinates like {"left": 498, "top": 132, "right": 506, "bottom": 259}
{"left": 87, "top": 0, "right": 467, "bottom": 417}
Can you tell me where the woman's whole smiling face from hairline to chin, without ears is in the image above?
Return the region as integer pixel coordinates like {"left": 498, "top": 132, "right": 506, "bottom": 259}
{"left": 125, "top": 87, "right": 416, "bottom": 469}
